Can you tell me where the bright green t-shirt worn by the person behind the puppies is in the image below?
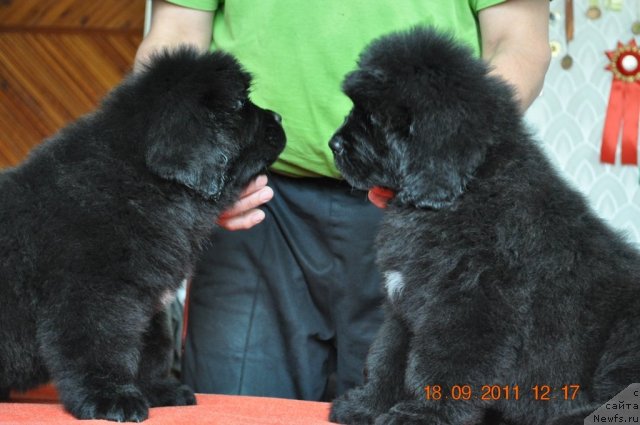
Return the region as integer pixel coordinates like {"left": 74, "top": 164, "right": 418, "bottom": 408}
{"left": 170, "top": 0, "right": 505, "bottom": 177}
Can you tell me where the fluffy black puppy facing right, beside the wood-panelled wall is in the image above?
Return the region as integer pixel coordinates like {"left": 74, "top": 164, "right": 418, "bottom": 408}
{"left": 0, "top": 48, "right": 285, "bottom": 421}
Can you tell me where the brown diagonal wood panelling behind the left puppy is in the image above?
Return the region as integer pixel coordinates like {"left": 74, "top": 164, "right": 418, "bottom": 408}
{"left": 0, "top": 0, "right": 145, "bottom": 168}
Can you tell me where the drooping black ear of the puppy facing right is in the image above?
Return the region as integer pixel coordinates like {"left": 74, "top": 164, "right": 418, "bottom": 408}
{"left": 145, "top": 113, "right": 229, "bottom": 198}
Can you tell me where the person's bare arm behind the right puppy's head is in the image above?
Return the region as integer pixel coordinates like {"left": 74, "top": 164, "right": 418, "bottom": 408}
{"left": 478, "top": 0, "right": 551, "bottom": 111}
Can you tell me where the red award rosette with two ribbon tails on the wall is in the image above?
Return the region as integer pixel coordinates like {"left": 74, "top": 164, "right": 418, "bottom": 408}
{"left": 600, "top": 40, "right": 640, "bottom": 164}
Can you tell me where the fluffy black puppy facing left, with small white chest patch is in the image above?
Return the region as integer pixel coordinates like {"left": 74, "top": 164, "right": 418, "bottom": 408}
{"left": 330, "top": 29, "right": 640, "bottom": 425}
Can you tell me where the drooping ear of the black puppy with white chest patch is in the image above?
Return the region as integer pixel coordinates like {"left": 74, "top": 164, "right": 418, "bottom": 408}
{"left": 396, "top": 132, "right": 486, "bottom": 209}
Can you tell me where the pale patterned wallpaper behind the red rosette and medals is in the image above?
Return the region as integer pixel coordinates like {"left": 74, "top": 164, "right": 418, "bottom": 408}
{"left": 526, "top": 0, "right": 640, "bottom": 247}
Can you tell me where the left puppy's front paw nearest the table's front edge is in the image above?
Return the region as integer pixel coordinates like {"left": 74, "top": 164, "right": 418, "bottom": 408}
{"left": 65, "top": 385, "right": 149, "bottom": 422}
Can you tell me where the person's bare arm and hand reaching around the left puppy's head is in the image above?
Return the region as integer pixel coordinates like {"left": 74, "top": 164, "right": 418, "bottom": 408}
{"left": 133, "top": 0, "right": 273, "bottom": 230}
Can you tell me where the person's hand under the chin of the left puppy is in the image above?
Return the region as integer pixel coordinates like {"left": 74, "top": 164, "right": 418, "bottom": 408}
{"left": 218, "top": 175, "right": 273, "bottom": 230}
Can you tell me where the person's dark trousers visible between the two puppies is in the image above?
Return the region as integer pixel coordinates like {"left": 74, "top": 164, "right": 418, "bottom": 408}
{"left": 182, "top": 174, "right": 382, "bottom": 400}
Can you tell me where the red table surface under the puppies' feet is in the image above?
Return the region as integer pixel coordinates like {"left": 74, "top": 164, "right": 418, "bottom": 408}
{"left": 0, "top": 387, "right": 331, "bottom": 425}
